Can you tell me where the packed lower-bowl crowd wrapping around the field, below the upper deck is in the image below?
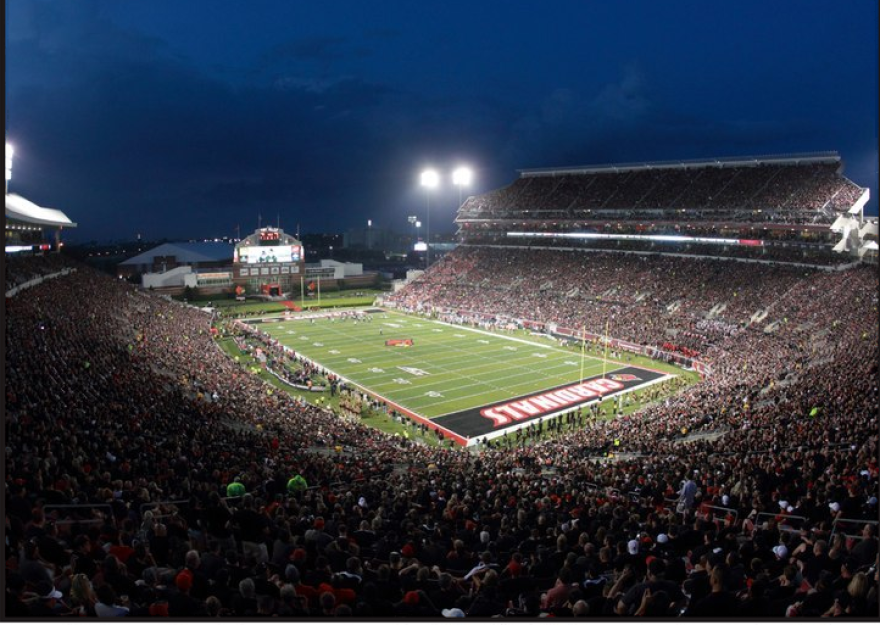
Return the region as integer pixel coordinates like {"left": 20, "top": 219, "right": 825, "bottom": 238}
{"left": 4, "top": 248, "right": 880, "bottom": 619}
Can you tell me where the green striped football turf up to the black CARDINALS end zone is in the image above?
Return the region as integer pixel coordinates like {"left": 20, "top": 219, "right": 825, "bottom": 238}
{"left": 251, "top": 311, "right": 669, "bottom": 419}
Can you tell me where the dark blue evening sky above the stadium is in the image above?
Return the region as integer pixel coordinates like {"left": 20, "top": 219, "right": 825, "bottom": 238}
{"left": 6, "top": 0, "right": 878, "bottom": 241}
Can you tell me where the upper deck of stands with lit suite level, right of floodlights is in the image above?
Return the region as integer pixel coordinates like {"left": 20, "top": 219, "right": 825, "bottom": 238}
{"left": 455, "top": 153, "right": 865, "bottom": 264}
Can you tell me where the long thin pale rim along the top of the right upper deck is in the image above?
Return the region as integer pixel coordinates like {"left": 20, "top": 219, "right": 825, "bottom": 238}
{"left": 517, "top": 151, "right": 840, "bottom": 178}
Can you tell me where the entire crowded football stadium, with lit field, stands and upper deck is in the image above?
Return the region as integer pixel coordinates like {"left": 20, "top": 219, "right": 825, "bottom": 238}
{"left": 5, "top": 147, "right": 880, "bottom": 620}
